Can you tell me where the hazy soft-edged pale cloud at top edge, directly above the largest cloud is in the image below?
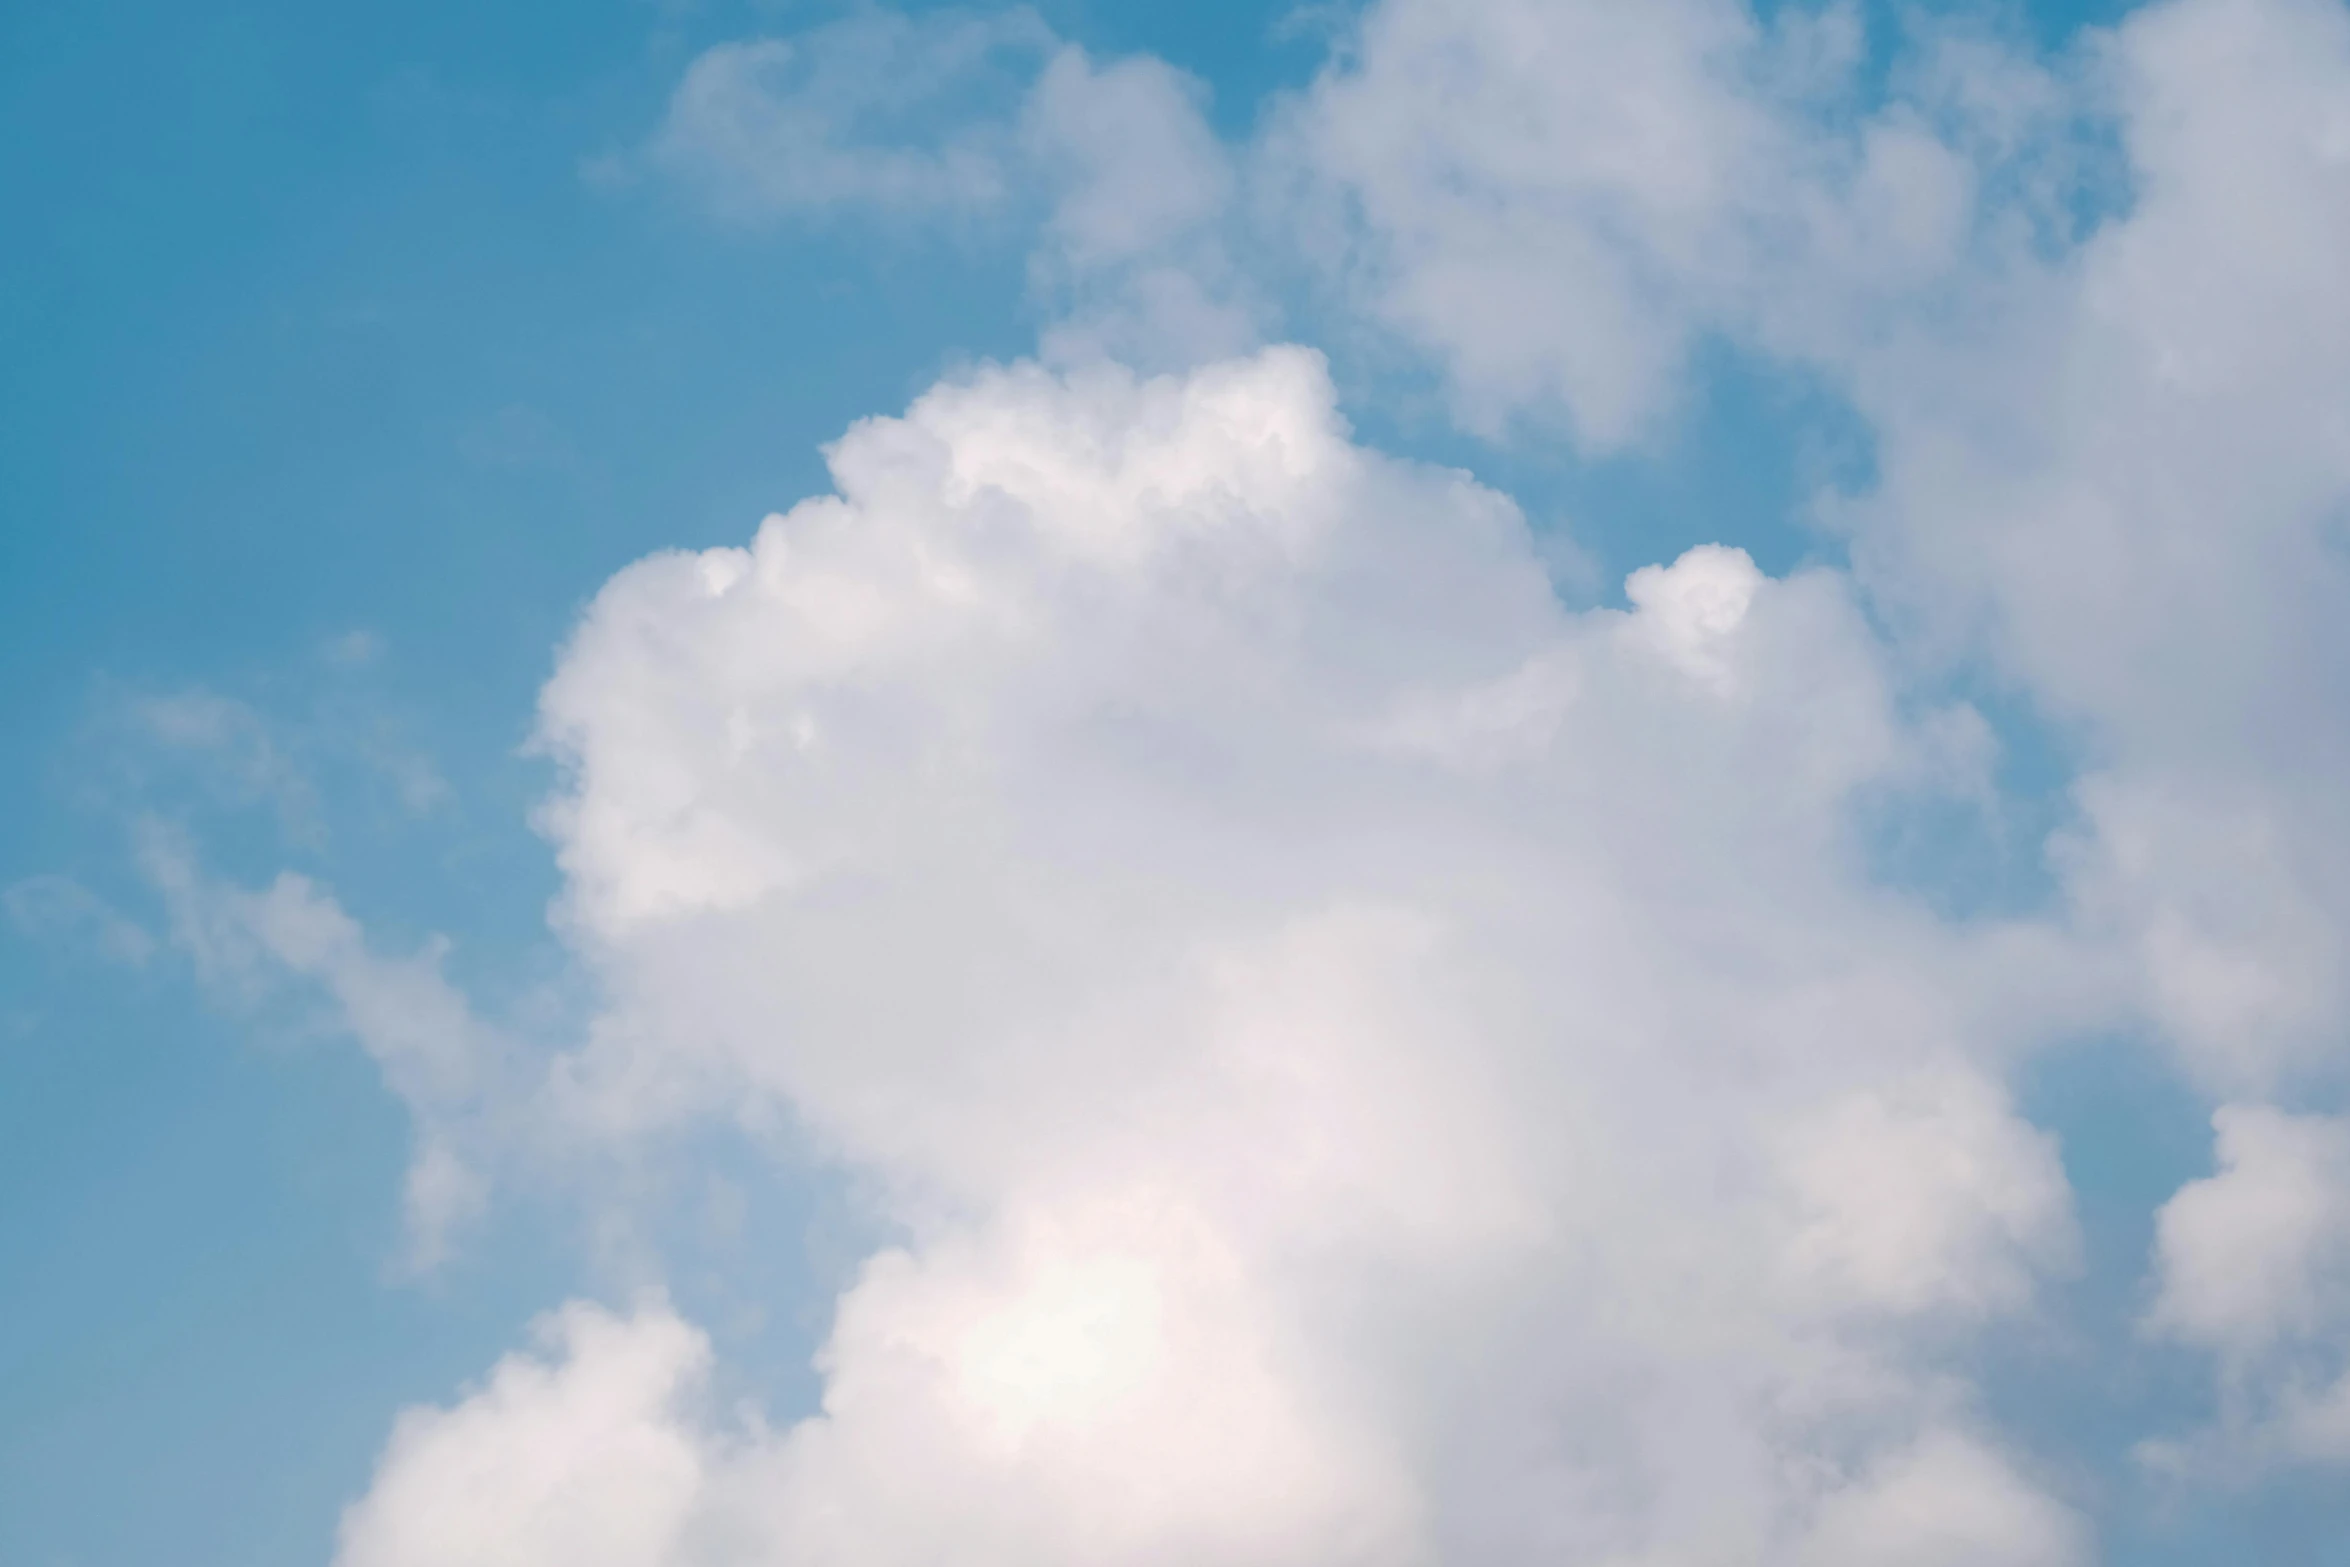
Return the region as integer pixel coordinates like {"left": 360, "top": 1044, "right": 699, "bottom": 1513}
{"left": 1276, "top": 0, "right": 1795, "bottom": 446}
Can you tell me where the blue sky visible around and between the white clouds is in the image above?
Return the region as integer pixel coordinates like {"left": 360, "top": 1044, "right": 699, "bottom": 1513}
{"left": 0, "top": 0, "right": 2350, "bottom": 1567}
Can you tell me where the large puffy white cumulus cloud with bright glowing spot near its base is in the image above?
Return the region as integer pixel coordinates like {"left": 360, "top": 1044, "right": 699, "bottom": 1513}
{"left": 343, "top": 350, "right": 2080, "bottom": 1567}
